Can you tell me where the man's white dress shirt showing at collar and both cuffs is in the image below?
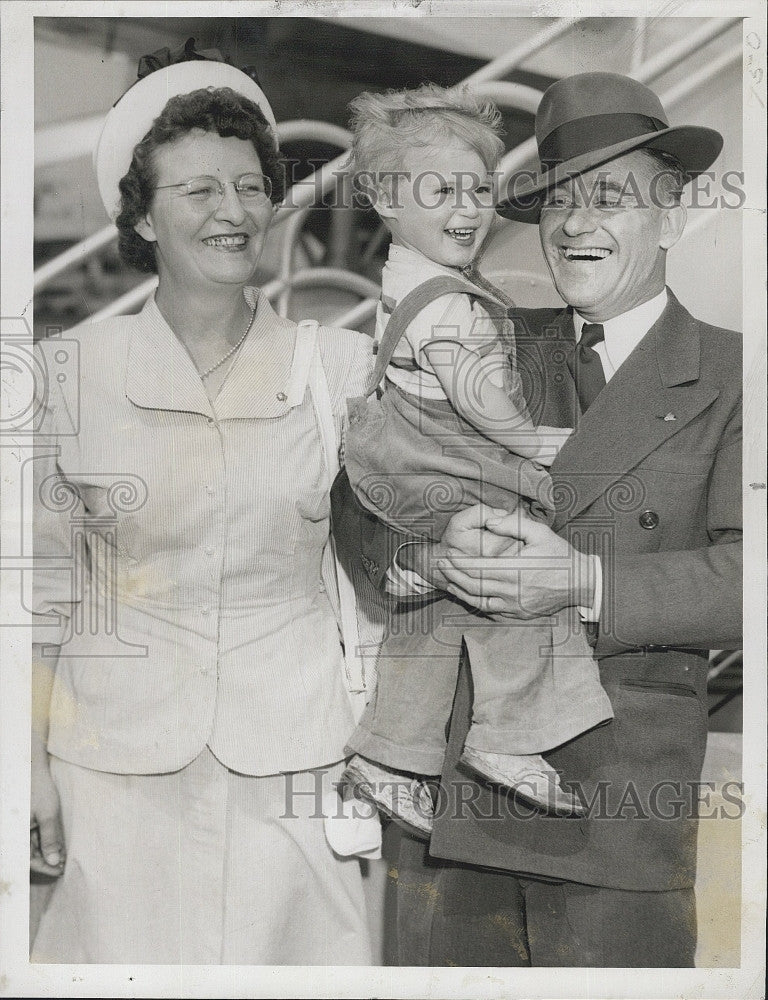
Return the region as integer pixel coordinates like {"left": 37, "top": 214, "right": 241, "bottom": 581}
{"left": 386, "top": 288, "right": 667, "bottom": 621}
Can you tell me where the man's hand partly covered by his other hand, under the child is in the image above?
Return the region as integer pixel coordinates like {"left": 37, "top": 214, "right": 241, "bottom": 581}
{"left": 398, "top": 504, "right": 521, "bottom": 590}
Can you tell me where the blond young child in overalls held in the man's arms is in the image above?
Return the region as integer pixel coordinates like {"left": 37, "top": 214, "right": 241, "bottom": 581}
{"left": 345, "top": 85, "right": 613, "bottom": 833}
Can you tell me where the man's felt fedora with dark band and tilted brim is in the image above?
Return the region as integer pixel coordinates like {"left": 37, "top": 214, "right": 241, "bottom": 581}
{"left": 496, "top": 73, "right": 723, "bottom": 222}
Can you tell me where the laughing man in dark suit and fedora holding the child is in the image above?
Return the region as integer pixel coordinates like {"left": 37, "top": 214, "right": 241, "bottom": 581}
{"left": 332, "top": 73, "right": 741, "bottom": 967}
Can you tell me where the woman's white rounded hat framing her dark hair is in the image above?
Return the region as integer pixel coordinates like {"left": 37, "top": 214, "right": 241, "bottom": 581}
{"left": 93, "top": 59, "right": 277, "bottom": 221}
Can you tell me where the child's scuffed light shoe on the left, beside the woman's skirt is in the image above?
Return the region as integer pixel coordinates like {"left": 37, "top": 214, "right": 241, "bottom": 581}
{"left": 341, "top": 754, "right": 434, "bottom": 838}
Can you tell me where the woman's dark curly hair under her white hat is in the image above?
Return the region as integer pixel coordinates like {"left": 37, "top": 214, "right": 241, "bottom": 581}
{"left": 115, "top": 87, "right": 285, "bottom": 273}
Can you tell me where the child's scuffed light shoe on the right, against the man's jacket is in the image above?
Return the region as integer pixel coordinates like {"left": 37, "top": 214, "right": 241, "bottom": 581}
{"left": 461, "top": 747, "right": 584, "bottom": 816}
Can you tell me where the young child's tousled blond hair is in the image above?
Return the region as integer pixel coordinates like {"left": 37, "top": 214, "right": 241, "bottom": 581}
{"left": 349, "top": 83, "right": 504, "bottom": 176}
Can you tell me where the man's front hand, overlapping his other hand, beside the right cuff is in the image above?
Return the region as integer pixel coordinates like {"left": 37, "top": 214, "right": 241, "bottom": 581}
{"left": 437, "top": 508, "right": 595, "bottom": 619}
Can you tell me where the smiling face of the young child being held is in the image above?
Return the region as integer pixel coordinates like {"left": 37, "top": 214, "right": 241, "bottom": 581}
{"left": 379, "top": 139, "right": 495, "bottom": 267}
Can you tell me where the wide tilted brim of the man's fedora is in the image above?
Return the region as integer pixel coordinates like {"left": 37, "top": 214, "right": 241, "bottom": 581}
{"left": 496, "top": 125, "right": 723, "bottom": 223}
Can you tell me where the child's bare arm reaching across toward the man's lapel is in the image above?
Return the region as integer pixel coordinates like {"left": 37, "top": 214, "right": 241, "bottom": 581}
{"left": 421, "top": 339, "right": 571, "bottom": 465}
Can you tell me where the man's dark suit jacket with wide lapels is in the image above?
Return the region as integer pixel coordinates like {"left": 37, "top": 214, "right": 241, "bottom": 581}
{"left": 335, "top": 292, "right": 742, "bottom": 890}
